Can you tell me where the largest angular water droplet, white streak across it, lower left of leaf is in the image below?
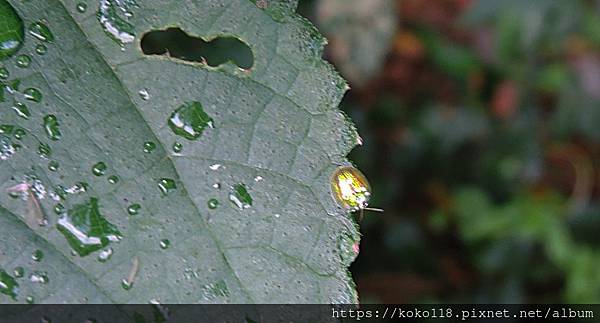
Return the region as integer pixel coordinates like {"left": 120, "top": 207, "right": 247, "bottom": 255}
{"left": 57, "top": 197, "right": 121, "bottom": 257}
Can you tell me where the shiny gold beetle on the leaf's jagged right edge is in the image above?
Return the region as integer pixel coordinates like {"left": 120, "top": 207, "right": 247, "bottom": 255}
{"left": 330, "top": 166, "right": 383, "bottom": 220}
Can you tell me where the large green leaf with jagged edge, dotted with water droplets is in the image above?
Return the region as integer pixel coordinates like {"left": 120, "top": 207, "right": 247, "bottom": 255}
{"left": 0, "top": 0, "right": 358, "bottom": 303}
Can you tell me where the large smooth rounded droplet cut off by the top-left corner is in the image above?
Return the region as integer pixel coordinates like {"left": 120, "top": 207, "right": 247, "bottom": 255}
{"left": 0, "top": 0, "right": 25, "bottom": 61}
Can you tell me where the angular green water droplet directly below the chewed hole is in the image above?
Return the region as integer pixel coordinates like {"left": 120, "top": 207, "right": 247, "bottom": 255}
{"left": 168, "top": 101, "right": 213, "bottom": 140}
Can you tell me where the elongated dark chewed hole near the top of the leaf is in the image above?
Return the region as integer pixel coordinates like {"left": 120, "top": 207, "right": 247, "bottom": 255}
{"left": 141, "top": 28, "right": 254, "bottom": 70}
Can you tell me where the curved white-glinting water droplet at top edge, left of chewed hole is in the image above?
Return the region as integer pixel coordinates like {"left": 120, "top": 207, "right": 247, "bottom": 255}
{"left": 98, "top": 0, "right": 137, "bottom": 45}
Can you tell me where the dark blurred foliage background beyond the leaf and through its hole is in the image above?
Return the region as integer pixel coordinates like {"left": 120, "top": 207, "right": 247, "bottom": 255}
{"left": 142, "top": 0, "right": 600, "bottom": 303}
